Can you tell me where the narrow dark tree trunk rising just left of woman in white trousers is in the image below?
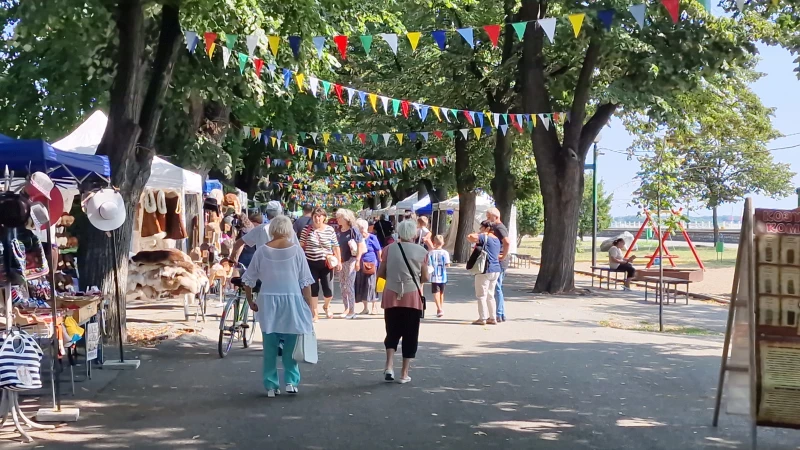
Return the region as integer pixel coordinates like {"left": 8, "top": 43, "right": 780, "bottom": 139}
{"left": 453, "top": 138, "right": 477, "bottom": 262}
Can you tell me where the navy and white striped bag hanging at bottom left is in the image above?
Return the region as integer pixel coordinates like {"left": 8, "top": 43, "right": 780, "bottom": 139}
{"left": 0, "top": 331, "right": 43, "bottom": 391}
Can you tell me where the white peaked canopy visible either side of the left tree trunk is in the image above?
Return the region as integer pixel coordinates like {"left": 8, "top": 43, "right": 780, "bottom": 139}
{"left": 53, "top": 111, "right": 203, "bottom": 194}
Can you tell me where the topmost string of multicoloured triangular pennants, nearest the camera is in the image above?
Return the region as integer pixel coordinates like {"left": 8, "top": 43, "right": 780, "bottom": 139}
{"left": 184, "top": 0, "right": 684, "bottom": 63}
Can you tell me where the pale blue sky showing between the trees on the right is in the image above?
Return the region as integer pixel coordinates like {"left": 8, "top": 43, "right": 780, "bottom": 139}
{"left": 587, "top": 45, "right": 800, "bottom": 220}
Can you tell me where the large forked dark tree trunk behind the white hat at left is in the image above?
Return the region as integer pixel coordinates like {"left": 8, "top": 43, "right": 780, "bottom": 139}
{"left": 78, "top": 0, "right": 181, "bottom": 342}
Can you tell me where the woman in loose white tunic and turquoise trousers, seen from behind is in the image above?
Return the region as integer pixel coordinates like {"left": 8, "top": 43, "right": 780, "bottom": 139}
{"left": 242, "top": 216, "right": 314, "bottom": 397}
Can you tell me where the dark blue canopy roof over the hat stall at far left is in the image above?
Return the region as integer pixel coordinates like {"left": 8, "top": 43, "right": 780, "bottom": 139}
{"left": 0, "top": 134, "right": 111, "bottom": 179}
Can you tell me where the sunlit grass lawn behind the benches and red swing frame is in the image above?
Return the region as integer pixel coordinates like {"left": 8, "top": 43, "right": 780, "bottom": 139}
{"left": 517, "top": 237, "right": 736, "bottom": 269}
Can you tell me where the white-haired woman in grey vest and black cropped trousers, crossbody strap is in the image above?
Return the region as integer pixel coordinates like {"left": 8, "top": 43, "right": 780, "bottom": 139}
{"left": 378, "top": 220, "right": 428, "bottom": 384}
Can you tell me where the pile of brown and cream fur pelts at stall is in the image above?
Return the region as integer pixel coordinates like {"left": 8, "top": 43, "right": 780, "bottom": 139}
{"left": 127, "top": 249, "right": 209, "bottom": 300}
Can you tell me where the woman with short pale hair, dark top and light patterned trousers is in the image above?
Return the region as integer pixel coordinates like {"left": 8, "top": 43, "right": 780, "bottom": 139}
{"left": 336, "top": 209, "right": 367, "bottom": 319}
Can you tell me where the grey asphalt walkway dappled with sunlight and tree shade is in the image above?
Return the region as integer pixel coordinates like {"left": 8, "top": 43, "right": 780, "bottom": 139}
{"left": 0, "top": 270, "right": 800, "bottom": 450}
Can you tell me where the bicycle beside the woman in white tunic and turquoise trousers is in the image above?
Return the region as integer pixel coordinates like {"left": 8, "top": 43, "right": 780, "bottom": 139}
{"left": 217, "top": 277, "right": 258, "bottom": 358}
